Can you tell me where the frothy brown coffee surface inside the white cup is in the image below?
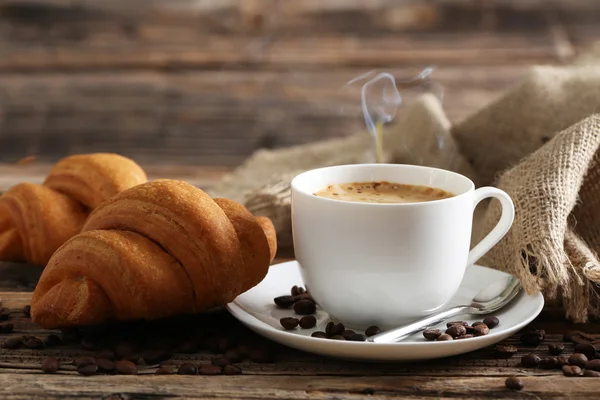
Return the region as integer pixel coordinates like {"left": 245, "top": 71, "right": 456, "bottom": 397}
{"left": 314, "top": 181, "right": 454, "bottom": 203}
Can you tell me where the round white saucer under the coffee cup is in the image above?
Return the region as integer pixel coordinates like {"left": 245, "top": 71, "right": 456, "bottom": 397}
{"left": 227, "top": 261, "right": 544, "bottom": 361}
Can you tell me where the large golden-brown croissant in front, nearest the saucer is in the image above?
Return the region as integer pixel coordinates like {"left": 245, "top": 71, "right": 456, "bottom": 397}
{"left": 31, "top": 179, "right": 277, "bottom": 329}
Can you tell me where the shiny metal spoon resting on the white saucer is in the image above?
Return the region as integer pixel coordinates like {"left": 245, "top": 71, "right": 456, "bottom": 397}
{"left": 367, "top": 276, "right": 521, "bottom": 343}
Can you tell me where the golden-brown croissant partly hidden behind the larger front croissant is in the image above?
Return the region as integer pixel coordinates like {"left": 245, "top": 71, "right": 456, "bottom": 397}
{"left": 0, "top": 153, "right": 147, "bottom": 266}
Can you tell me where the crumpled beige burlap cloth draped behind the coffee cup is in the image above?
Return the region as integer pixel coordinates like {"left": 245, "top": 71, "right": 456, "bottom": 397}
{"left": 210, "top": 52, "right": 600, "bottom": 322}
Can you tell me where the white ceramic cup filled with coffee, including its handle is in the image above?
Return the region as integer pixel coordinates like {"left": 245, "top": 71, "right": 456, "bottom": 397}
{"left": 291, "top": 164, "right": 514, "bottom": 329}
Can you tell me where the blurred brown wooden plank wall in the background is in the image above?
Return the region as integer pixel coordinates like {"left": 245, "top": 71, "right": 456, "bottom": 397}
{"left": 0, "top": 0, "right": 600, "bottom": 167}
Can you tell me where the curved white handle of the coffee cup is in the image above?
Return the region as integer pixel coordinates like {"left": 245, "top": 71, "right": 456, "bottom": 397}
{"left": 467, "top": 186, "right": 515, "bottom": 267}
